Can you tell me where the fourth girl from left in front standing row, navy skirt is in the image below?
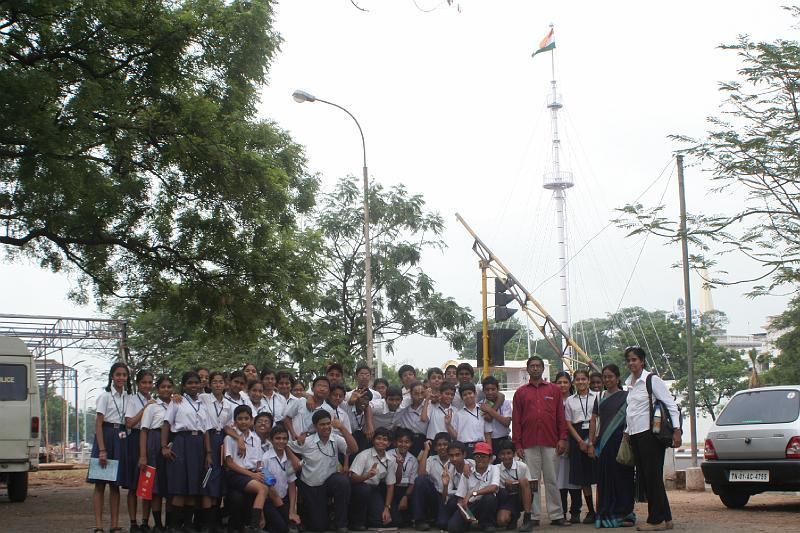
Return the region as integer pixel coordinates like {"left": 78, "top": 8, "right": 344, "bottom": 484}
{"left": 161, "top": 371, "right": 213, "bottom": 529}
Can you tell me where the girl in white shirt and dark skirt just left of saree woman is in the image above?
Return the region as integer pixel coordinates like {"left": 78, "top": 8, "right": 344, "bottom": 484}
{"left": 564, "top": 370, "right": 597, "bottom": 524}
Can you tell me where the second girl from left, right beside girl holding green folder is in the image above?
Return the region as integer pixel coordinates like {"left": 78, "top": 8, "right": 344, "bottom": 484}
{"left": 119, "top": 370, "right": 155, "bottom": 531}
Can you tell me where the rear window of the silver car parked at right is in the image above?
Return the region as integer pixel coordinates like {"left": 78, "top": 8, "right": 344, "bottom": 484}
{"left": 717, "top": 390, "right": 800, "bottom": 426}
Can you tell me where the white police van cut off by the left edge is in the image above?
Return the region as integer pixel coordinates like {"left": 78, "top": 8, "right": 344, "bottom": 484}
{"left": 0, "top": 336, "right": 40, "bottom": 502}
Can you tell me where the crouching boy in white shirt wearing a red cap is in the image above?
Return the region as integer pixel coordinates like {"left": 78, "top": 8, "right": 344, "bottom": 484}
{"left": 447, "top": 438, "right": 500, "bottom": 533}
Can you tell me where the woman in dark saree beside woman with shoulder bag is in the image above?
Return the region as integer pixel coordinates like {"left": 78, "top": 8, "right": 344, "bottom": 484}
{"left": 589, "top": 364, "right": 636, "bottom": 528}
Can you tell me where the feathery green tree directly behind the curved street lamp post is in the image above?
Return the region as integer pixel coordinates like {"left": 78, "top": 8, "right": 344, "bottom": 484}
{"left": 292, "top": 177, "right": 473, "bottom": 376}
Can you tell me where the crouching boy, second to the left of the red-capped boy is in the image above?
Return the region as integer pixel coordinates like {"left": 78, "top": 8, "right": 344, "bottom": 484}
{"left": 412, "top": 432, "right": 453, "bottom": 531}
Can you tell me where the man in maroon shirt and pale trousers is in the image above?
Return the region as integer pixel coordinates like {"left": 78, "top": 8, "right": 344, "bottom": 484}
{"left": 511, "top": 356, "right": 570, "bottom": 526}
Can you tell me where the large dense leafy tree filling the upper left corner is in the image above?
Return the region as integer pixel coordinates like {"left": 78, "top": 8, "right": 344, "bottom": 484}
{"left": 0, "top": 0, "right": 317, "bottom": 339}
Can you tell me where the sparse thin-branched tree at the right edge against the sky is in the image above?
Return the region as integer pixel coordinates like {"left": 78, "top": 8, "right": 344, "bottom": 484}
{"left": 618, "top": 7, "right": 800, "bottom": 295}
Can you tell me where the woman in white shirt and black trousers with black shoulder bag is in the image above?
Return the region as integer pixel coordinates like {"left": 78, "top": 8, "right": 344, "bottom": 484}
{"left": 624, "top": 346, "right": 682, "bottom": 531}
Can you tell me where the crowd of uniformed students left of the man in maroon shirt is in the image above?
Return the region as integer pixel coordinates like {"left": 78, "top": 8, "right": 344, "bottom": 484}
{"left": 88, "top": 363, "right": 527, "bottom": 533}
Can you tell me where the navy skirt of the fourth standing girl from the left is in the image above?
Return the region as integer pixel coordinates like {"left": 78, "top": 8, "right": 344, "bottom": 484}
{"left": 167, "top": 431, "right": 206, "bottom": 496}
